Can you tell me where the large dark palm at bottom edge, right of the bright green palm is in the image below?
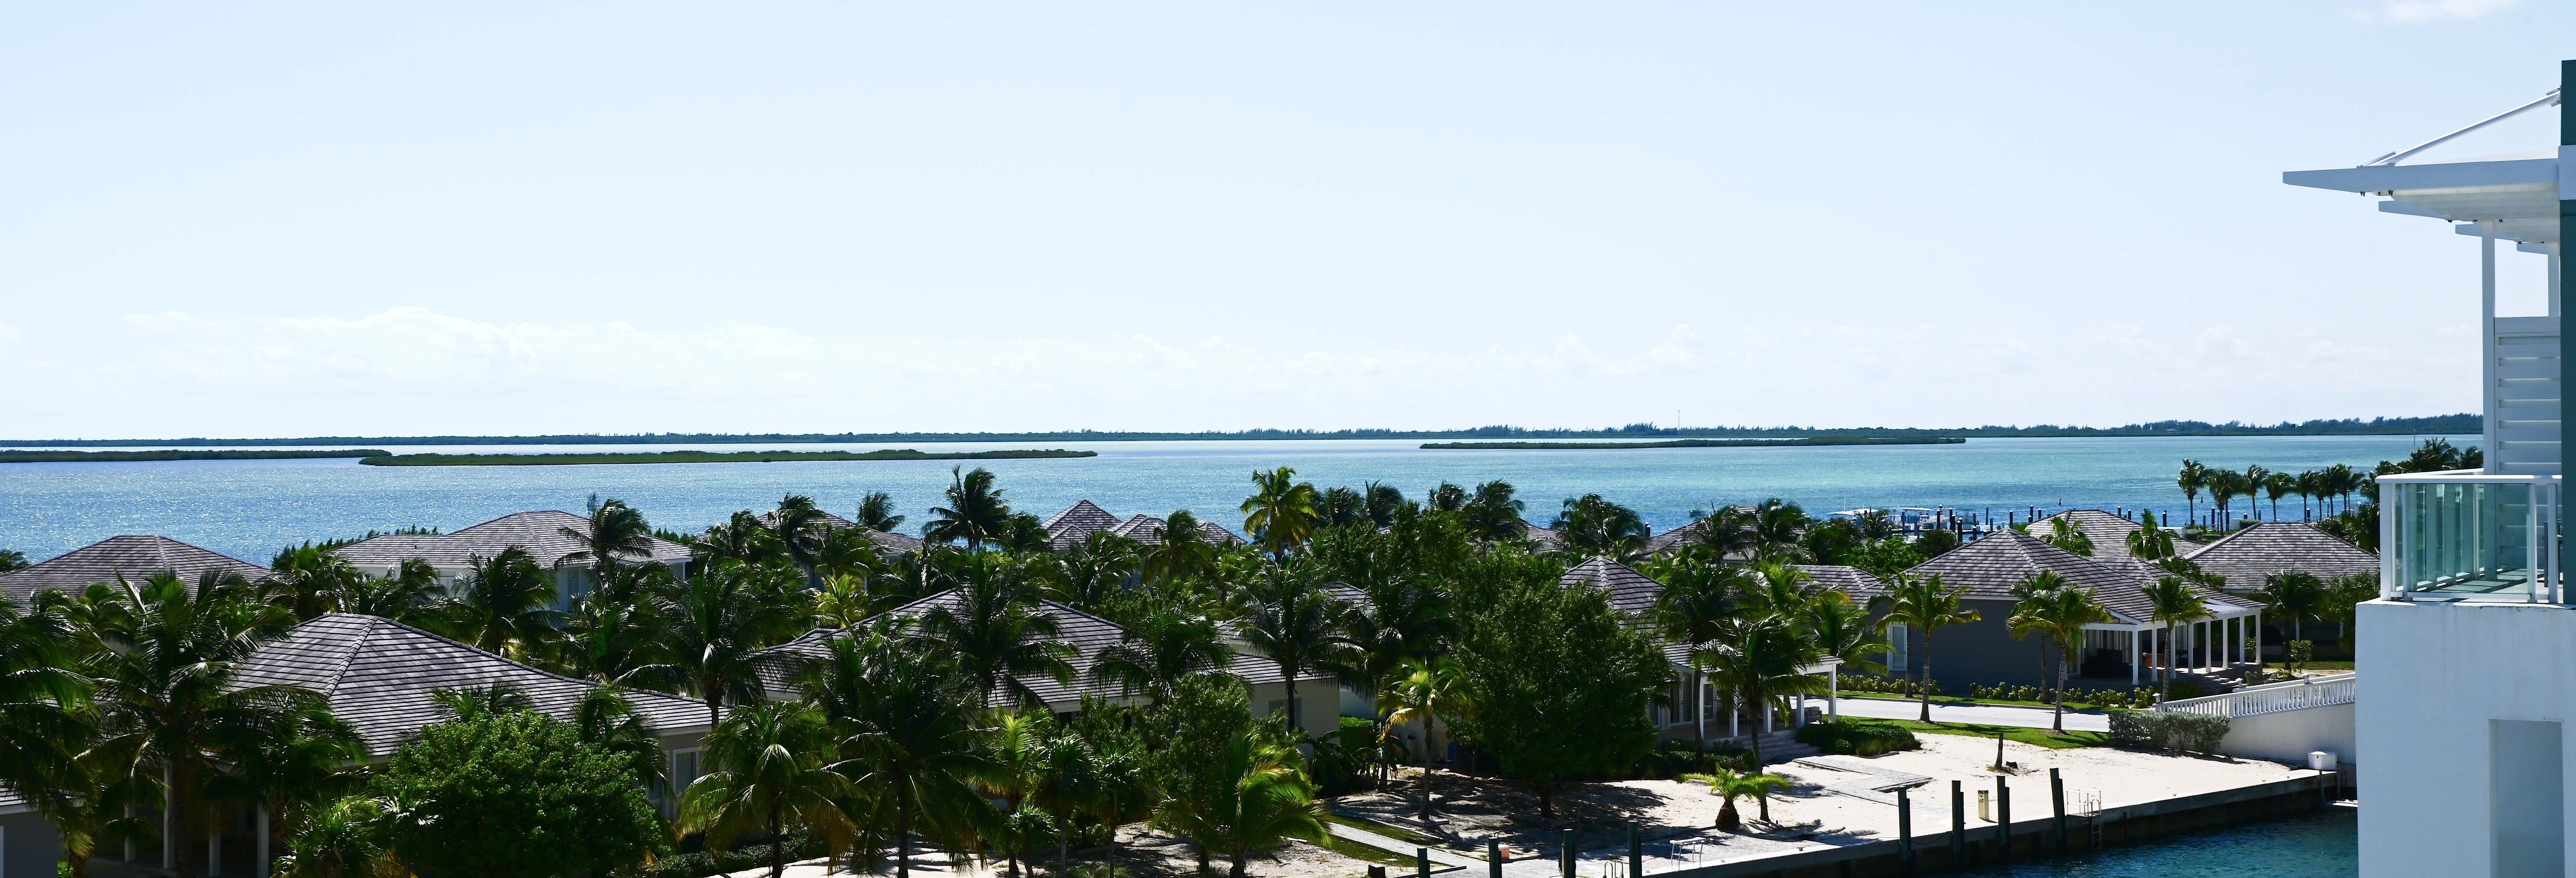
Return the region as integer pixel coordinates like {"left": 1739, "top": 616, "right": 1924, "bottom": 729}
{"left": 799, "top": 623, "right": 992, "bottom": 878}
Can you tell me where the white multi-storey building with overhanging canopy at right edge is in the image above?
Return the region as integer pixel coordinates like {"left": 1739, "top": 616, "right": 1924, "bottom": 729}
{"left": 2283, "top": 62, "right": 2576, "bottom": 878}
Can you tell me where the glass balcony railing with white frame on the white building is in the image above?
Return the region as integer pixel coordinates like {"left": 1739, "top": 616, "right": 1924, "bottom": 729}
{"left": 2380, "top": 471, "right": 2566, "bottom": 603}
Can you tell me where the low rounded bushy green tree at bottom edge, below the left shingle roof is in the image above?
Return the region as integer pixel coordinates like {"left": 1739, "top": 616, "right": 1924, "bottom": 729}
{"left": 374, "top": 711, "right": 670, "bottom": 878}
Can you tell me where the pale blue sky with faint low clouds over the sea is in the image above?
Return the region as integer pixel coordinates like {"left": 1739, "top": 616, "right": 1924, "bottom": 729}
{"left": 0, "top": 0, "right": 2576, "bottom": 438}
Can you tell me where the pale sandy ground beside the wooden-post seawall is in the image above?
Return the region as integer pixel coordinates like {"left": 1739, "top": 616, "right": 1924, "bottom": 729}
{"left": 1340, "top": 734, "right": 2295, "bottom": 852}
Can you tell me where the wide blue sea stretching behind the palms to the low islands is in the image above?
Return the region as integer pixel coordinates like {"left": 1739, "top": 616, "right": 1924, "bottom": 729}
{"left": 0, "top": 435, "right": 2475, "bottom": 561}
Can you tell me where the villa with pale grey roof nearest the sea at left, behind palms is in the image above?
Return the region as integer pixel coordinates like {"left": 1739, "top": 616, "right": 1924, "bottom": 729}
{"left": 332, "top": 510, "right": 690, "bottom": 603}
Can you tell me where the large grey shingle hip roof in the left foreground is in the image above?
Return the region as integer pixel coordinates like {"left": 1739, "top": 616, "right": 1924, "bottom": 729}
{"left": 234, "top": 613, "right": 706, "bottom": 760}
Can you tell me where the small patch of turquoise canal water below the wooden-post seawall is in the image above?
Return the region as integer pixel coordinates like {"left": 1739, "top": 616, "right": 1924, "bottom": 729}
{"left": 1950, "top": 809, "right": 2360, "bottom": 878}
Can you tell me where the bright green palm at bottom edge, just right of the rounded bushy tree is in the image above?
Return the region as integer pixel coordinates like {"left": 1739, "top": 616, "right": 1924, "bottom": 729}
{"left": 680, "top": 703, "right": 858, "bottom": 878}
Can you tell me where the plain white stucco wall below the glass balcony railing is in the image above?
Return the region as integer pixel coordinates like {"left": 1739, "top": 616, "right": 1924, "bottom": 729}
{"left": 2355, "top": 600, "right": 2576, "bottom": 878}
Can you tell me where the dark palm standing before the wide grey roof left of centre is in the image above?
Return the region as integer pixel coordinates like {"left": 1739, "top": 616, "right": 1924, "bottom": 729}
{"left": 922, "top": 556, "right": 1074, "bottom": 708}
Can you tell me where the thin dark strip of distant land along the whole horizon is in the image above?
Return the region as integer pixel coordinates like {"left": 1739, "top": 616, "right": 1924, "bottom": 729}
{"left": 0, "top": 415, "right": 2486, "bottom": 448}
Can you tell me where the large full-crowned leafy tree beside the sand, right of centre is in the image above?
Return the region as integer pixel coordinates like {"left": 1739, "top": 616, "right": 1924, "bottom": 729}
{"left": 1453, "top": 582, "right": 1672, "bottom": 816}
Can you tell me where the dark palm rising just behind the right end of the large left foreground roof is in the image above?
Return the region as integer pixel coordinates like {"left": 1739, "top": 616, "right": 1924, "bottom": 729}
{"left": 664, "top": 561, "right": 804, "bottom": 726}
